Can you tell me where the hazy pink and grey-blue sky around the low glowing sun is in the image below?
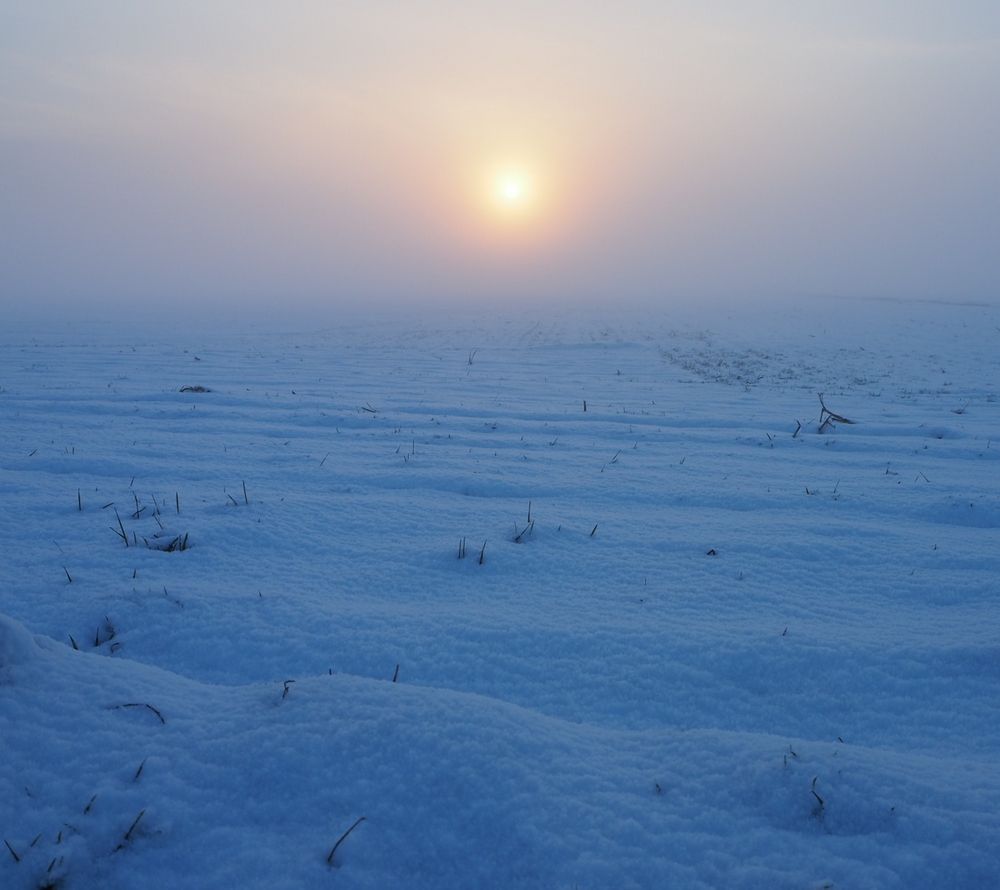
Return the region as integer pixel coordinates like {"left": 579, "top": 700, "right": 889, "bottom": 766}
{"left": 0, "top": 0, "right": 1000, "bottom": 314}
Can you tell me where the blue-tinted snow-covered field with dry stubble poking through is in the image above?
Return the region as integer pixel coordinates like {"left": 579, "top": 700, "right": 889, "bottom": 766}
{"left": 0, "top": 304, "right": 1000, "bottom": 890}
